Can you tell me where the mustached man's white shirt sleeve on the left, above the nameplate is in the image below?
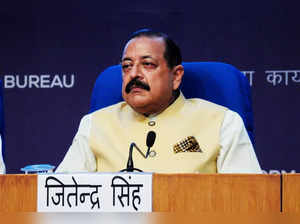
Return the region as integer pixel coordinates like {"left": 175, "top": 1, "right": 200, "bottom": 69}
{"left": 55, "top": 115, "right": 96, "bottom": 173}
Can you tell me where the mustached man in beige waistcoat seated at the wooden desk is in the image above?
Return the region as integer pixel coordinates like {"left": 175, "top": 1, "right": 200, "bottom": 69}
{"left": 56, "top": 30, "right": 261, "bottom": 173}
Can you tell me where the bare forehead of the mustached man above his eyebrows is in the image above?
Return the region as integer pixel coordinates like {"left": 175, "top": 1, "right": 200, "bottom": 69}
{"left": 122, "top": 36, "right": 165, "bottom": 61}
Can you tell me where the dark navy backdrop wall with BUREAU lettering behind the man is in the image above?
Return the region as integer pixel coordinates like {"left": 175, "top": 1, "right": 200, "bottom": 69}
{"left": 0, "top": 0, "right": 300, "bottom": 173}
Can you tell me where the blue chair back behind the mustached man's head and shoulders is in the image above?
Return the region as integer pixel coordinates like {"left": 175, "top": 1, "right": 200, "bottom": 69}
{"left": 90, "top": 62, "right": 254, "bottom": 143}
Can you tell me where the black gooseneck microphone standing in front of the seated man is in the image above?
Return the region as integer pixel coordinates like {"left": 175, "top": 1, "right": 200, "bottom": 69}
{"left": 120, "top": 131, "right": 156, "bottom": 172}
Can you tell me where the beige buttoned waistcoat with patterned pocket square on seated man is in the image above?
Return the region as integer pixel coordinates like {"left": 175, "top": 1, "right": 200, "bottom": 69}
{"left": 89, "top": 94, "right": 227, "bottom": 173}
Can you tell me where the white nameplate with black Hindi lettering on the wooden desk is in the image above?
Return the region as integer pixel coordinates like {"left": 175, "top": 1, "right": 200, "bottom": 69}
{"left": 37, "top": 173, "right": 152, "bottom": 212}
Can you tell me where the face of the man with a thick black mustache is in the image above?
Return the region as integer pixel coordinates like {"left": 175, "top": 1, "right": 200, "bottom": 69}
{"left": 122, "top": 37, "right": 183, "bottom": 115}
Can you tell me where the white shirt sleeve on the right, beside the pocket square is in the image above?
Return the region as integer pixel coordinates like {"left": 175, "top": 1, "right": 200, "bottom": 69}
{"left": 217, "top": 110, "right": 262, "bottom": 174}
